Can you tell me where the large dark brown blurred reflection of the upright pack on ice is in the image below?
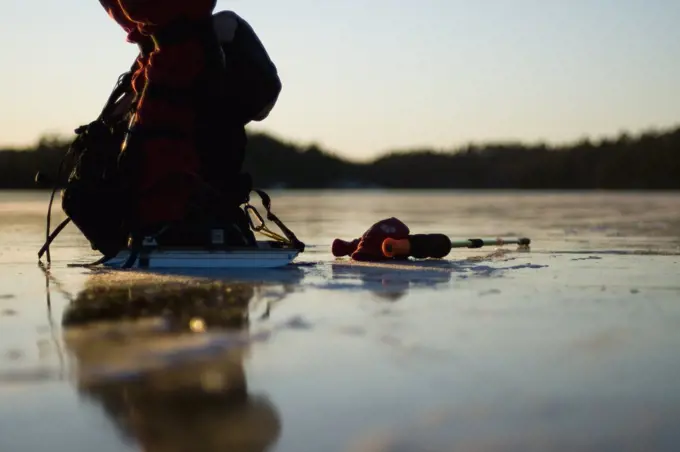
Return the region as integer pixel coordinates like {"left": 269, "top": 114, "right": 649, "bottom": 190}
{"left": 56, "top": 274, "right": 298, "bottom": 452}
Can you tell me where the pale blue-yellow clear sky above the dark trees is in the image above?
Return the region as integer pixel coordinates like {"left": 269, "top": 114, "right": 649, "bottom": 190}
{"left": 0, "top": 0, "right": 680, "bottom": 159}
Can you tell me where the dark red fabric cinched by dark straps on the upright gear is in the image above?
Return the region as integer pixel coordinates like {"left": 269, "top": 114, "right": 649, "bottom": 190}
{"left": 99, "top": 0, "right": 216, "bottom": 223}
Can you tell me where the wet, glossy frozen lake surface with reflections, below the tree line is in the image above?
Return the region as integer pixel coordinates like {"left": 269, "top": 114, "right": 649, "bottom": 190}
{"left": 0, "top": 192, "right": 680, "bottom": 452}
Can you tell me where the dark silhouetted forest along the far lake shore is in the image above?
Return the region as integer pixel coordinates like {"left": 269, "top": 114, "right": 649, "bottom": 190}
{"left": 0, "top": 127, "right": 680, "bottom": 190}
